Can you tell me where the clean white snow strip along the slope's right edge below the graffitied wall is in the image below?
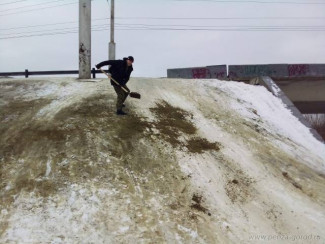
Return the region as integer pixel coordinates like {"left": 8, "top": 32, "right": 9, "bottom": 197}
{"left": 209, "top": 81, "right": 325, "bottom": 172}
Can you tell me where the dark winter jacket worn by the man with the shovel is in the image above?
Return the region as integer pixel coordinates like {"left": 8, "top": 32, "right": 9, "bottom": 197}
{"left": 96, "top": 58, "right": 133, "bottom": 86}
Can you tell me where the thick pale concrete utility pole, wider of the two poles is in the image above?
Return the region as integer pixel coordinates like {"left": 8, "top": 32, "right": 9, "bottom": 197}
{"left": 79, "top": 0, "right": 91, "bottom": 79}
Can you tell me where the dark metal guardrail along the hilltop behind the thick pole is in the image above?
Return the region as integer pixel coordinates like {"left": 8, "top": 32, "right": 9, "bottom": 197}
{"left": 0, "top": 68, "right": 108, "bottom": 78}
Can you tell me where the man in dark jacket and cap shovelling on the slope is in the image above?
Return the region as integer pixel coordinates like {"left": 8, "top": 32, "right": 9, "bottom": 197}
{"left": 96, "top": 56, "right": 134, "bottom": 115}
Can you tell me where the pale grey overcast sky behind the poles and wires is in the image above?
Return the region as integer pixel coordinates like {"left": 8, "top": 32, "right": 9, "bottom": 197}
{"left": 0, "top": 0, "right": 325, "bottom": 77}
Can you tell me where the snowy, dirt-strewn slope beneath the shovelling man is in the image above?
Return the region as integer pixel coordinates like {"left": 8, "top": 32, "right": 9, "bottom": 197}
{"left": 0, "top": 78, "right": 325, "bottom": 243}
